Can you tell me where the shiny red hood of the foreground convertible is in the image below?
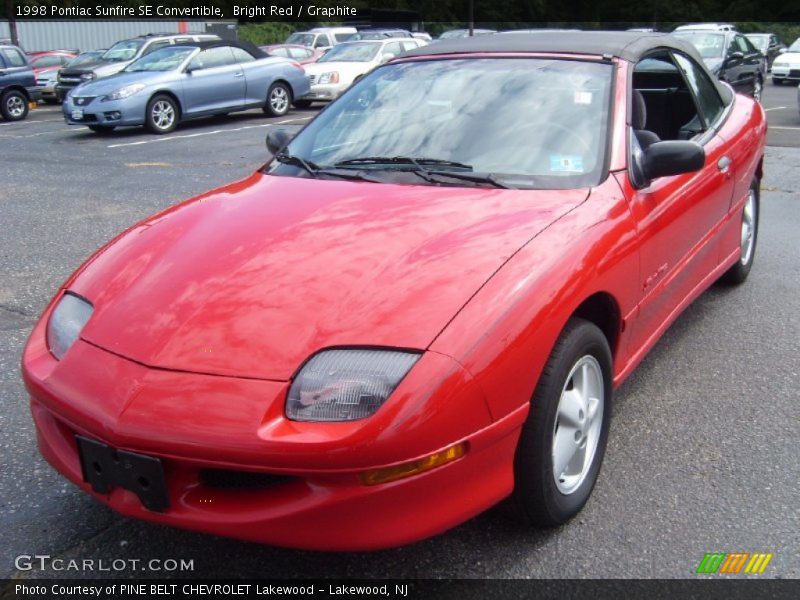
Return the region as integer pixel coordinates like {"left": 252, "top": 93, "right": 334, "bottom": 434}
{"left": 69, "top": 173, "right": 588, "bottom": 381}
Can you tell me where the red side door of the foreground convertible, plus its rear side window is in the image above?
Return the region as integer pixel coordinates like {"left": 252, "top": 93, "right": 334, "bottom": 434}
{"left": 630, "top": 53, "right": 733, "bottom": 352}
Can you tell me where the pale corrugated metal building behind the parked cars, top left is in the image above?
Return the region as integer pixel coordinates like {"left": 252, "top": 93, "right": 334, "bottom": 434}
{"left": 0, "top": 19, "right": 237, "bottom": 52}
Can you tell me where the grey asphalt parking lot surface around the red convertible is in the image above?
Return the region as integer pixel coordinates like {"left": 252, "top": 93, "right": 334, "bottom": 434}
{"left": 0, "top": 84, "right": 800, "bottom": 580}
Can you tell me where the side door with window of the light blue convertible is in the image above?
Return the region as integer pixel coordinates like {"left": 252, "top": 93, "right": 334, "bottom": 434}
{"left": 182, "top": 46, "right": 246, "bottom": 116}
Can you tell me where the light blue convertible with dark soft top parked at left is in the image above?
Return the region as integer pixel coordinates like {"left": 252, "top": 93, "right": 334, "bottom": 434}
{"left": 62, "top": 41, "right": 309, "bottom": 133}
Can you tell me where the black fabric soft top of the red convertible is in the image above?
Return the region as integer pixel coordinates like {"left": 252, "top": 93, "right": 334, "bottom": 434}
{"left": 403, "top": 29, "right": 732, "bottom": 104}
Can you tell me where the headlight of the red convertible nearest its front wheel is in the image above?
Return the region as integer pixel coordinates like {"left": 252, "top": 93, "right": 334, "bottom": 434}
{"left": 286, "top": 350, "right": 420, "bottom": 421}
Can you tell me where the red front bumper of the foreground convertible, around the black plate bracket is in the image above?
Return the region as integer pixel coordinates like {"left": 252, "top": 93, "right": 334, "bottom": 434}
{"left": 23, "top": 316, "right": 527, "bottom": 550}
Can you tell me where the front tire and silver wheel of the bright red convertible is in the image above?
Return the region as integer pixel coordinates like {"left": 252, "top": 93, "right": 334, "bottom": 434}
{"left": 508, "top": 318, "right": 613, "bottom": 527}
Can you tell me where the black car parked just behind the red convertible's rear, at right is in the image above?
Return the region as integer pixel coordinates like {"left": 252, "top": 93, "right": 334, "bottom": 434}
{"left": 672, "top": 29, "right": 767, "bottom": 101}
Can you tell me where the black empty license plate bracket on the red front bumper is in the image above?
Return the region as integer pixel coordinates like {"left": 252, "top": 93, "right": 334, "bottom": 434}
{"left": 75, "top": 435, "right": 169, "bottom": 512}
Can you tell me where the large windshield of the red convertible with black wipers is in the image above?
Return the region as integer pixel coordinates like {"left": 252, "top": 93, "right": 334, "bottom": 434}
{"left": 268, "top": 58, "right": 613, "bottom": 189}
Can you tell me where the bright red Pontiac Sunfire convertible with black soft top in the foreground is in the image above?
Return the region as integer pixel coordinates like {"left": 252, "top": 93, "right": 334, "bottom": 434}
{"left": 22, "top": 32, "right": 766, "bottom": 550}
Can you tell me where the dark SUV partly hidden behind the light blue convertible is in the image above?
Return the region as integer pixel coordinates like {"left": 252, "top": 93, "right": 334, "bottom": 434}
{"left": 56, "top": 33, "right": 219, "bottom": 100}
